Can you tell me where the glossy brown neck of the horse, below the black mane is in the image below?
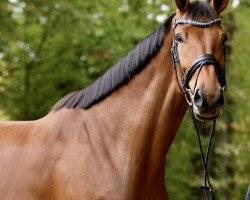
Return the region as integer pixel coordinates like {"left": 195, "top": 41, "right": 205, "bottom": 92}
{"left": 82, "top": 31, "right": 186, "bottom": 194}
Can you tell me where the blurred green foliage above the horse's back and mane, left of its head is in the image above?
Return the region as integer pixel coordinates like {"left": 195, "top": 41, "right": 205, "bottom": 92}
{"left": 0, "top": 0, "right": 170, "bottom": 119}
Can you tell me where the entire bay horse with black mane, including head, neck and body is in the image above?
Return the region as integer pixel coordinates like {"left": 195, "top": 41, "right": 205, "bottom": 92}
{"left": 0, "top": 0, "right": 228, "bottom": 200}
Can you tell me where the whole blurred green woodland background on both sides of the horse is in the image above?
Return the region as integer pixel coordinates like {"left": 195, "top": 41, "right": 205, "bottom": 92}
{"left": 0, "top": 0, "right": 250, "bottom": 200}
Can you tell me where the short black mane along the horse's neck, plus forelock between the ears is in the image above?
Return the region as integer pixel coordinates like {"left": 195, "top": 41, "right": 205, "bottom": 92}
{"left": 52, "top": 1, "right": 218, "bottom": 111}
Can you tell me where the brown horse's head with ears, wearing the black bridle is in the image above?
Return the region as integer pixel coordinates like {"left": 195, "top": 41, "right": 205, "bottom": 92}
{"left": 171, "top": 0, "right": 228, "bottom": 121}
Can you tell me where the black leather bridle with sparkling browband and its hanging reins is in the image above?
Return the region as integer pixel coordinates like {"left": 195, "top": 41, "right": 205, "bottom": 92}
{"left": 171, "top": 18, "right": 226, "bottom": 200}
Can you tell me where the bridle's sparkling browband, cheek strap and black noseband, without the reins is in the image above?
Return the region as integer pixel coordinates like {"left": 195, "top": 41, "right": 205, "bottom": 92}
{"left": 171, "top": 18, "right": 226, "bottom": 101}
